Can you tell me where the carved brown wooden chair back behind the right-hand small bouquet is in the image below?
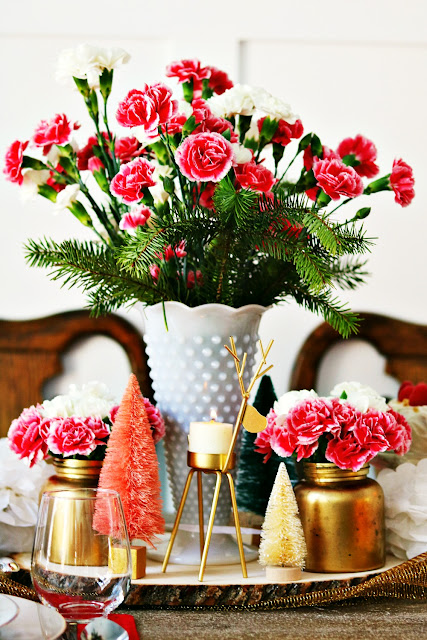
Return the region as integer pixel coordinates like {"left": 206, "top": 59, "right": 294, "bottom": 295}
{"left": 289, "top": 312, "right": 427, "bottom": 389}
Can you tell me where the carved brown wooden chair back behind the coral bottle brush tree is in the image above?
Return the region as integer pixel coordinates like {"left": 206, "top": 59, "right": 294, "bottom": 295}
{"left": 0, "top": 310, "right": 153, "bottom": 436}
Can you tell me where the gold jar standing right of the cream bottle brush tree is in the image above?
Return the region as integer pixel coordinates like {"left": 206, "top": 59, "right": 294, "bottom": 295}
{"left": 295, "top": 463, "right": 385, "bottom": 573}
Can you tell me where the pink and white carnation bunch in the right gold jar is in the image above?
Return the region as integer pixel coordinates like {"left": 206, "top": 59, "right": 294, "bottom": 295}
{"left": 255, "top": 382, "right": 411, "bottom": 471}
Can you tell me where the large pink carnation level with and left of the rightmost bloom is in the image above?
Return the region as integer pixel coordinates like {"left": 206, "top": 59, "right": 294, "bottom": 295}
{"left": 313, "top": 158, "right": 363, "bottom": 200}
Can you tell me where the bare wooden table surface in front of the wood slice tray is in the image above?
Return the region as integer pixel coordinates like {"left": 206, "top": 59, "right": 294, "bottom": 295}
{"left": 117, "top": 599, "right": 427, "bottom": 640}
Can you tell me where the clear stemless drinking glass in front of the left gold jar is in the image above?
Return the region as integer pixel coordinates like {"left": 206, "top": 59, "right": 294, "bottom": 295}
{"left": 31, "top": 489, "right": 131, "bottom": 622}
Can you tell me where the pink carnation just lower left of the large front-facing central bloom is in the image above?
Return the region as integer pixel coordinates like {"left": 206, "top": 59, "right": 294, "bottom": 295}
{"left": 110, "top": 158, "right": 156, "bottom": 203}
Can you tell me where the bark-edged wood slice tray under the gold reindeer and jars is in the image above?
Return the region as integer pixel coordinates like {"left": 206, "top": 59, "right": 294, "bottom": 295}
{"left": 125, "top": 556, "right": 402, "bottom": 608}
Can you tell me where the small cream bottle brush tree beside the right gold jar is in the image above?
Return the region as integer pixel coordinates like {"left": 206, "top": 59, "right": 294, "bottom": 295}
{"left": 259, "top": 462, "right": 307, "bottom": 582}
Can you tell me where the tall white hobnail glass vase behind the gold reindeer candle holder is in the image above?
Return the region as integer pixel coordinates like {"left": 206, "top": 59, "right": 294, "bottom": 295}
{"left": 142, "top": 301, "right": 265, "bottom": 564}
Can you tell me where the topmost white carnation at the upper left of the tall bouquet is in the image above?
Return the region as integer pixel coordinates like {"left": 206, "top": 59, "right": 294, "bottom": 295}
{"left": 56, "top": 44, "right": 130, "bottom": 89}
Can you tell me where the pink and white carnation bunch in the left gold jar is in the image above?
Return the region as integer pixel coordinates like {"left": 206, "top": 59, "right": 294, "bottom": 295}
{"left": 8, "top": 382, "right": 165, "bottom": 467}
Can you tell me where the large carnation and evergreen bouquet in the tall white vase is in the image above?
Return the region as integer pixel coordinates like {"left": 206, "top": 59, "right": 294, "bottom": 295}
{"left": 4, "top": 45, "right": 414, "bottom": 336}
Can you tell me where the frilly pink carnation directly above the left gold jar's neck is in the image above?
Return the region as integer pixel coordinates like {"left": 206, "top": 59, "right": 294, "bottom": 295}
{"left": 47, "top": 416, "right": 109, "bottom": 458}
